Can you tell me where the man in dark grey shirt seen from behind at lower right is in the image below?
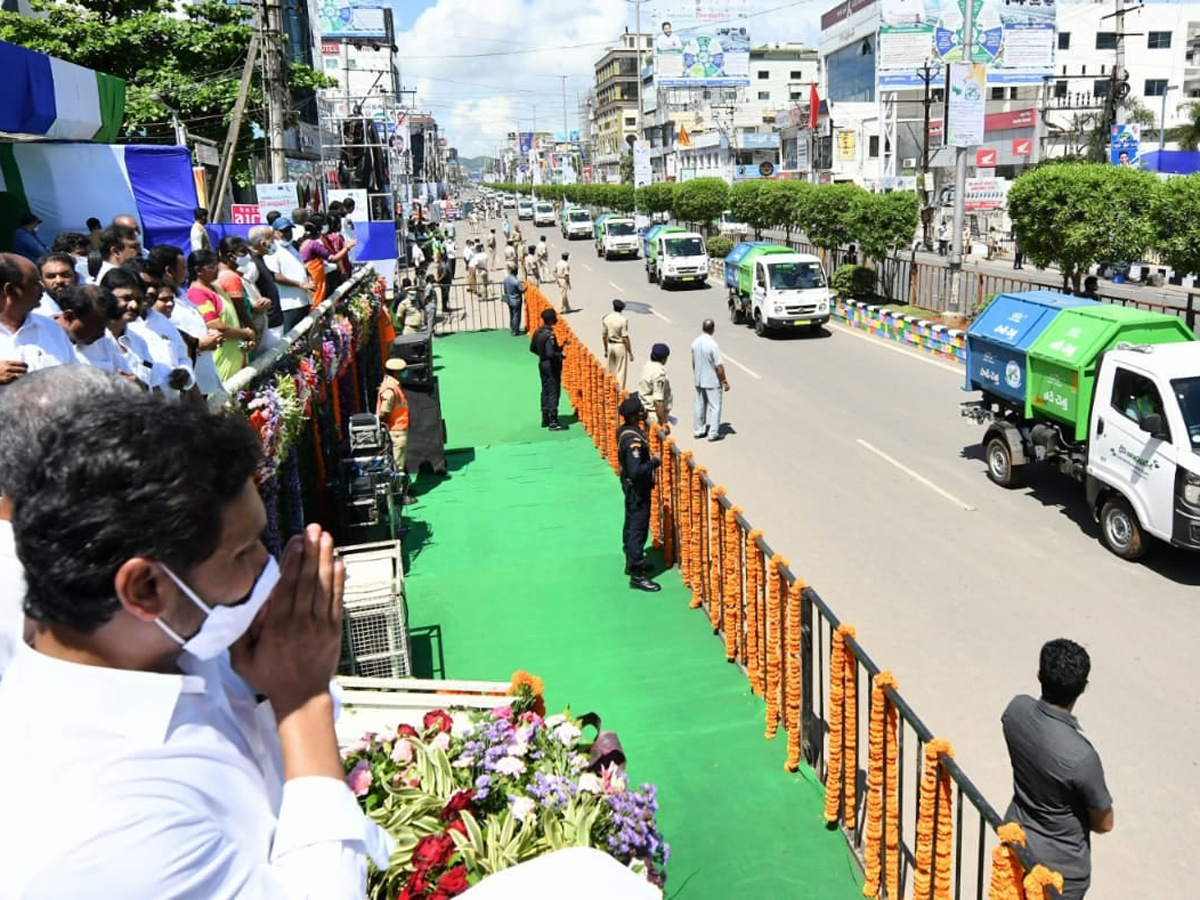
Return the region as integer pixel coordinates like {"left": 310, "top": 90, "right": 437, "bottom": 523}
{"left": 1001, "top": 637, "right": 1114, "bottom": 900}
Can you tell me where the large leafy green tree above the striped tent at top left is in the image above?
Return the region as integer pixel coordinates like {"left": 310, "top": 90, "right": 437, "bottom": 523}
{"left": 0, "top": 0, "right": 336, "bottom": 184}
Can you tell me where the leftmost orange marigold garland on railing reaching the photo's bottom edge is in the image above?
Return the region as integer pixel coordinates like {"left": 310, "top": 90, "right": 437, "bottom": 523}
{"left": 863, "top": 671, "right": 902, "bottom": 900}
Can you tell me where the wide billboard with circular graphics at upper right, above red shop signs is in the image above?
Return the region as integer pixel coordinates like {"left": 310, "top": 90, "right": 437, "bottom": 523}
{"left": 877, "top": 0, "right": 1057, "bottom": 90}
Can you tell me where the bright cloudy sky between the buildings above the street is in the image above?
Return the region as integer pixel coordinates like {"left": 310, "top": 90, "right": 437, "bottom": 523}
{"left": 396, "top": 0, "right": 835, "bottom": 156}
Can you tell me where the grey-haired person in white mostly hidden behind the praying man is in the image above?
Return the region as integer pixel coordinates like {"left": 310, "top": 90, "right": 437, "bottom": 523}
{"left": 0, "top": 362, "right": 137, "bottom": 678}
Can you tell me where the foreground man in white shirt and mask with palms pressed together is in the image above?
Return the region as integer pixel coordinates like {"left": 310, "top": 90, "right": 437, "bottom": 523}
{"left": 0, "top": 396, "right": 390, "bottom": 900}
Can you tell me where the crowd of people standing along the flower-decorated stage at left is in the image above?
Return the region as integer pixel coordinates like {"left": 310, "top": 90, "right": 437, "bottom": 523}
{"left": 0, "top": 206, "right": 358, "bottom": 401}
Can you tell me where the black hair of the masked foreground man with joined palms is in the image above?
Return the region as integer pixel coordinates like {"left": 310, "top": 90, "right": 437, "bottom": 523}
{"left": 13, "top": 395, "right": 260, "bottom": 632}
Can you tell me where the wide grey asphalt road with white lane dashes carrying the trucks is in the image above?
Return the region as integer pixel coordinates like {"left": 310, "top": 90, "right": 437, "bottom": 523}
{"left": 480, "top": 207, "right": 1200, "bottom": 900}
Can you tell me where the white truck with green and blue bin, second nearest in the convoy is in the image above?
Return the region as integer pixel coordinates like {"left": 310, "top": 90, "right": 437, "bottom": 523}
{"left": 725, "top": 241, "right": 832, "bottom": 337}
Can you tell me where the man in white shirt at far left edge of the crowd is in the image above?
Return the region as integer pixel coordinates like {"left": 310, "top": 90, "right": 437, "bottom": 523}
{"left": 0, "top": 253, "right": 74, "bottom": 394}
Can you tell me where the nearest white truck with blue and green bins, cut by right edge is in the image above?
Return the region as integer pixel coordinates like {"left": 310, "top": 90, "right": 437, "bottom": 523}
{"left": 961, "top": 296, "right": 1200, "bottom": 559}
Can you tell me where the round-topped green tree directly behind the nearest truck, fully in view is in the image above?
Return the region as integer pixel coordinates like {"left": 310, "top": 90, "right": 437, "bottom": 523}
{"left": 1008, "top": 163, "right": 1160, "bottom": 290}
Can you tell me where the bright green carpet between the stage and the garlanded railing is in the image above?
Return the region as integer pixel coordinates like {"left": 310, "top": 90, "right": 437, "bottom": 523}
{"left": 406, "top": 332, "right": 862, "bottom": 900}
